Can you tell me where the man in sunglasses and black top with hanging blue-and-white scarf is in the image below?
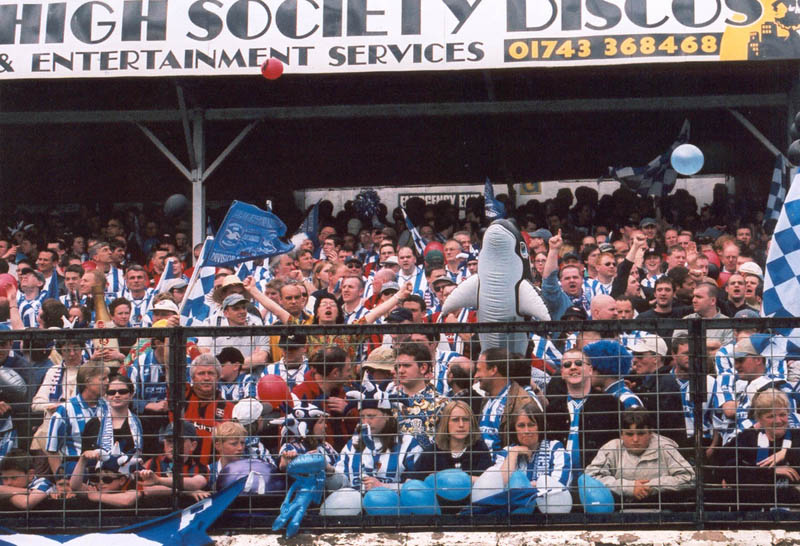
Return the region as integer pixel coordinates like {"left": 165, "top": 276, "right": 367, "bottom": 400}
{"left": 545, "top": 349, "right": 622, "bottom": 475}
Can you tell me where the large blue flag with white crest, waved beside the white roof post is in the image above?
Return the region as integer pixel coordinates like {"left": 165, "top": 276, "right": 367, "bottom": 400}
{"left": 204, "top": 201, "right": 294, "bottom": 267}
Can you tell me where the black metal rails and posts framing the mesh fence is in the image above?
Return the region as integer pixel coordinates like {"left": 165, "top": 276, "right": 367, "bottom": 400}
{"left": 0, "top": 318, "right": 800, "bottom": 533}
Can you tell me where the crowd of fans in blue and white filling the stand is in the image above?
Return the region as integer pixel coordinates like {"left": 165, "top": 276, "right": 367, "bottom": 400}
{"left": 0, "top": 181, "right": 800, "bottom": 510}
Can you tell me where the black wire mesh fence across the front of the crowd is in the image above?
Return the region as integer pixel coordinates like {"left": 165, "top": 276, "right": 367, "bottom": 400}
{"left": 0, "top": 319, "right": 800, "bottom": 533}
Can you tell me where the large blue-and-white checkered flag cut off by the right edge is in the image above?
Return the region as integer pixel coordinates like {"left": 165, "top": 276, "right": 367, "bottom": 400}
{"left": 761, "top": 175, "right": 800, "bottom": 343}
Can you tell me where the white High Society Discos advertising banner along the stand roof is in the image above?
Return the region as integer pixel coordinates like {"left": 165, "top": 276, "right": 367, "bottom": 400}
{"left": 0, "top": 0, "right": 800, "bottom": 79}
